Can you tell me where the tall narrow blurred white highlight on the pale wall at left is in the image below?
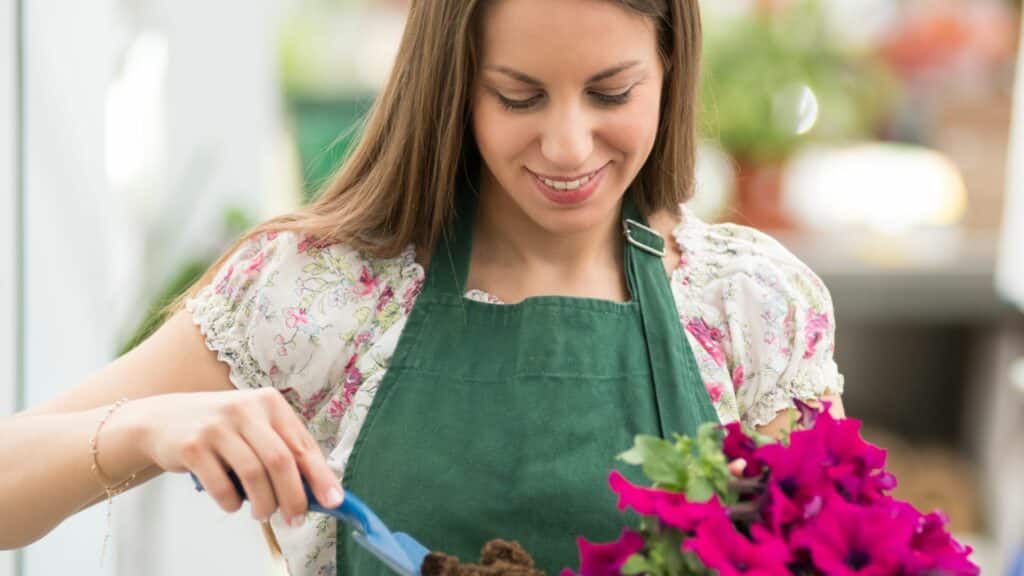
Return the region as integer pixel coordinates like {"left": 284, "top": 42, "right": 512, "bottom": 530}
{"left": 106, "top": 32, "right": 168, "bottom": 188}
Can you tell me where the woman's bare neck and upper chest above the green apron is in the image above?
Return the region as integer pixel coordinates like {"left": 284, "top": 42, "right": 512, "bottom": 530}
{"left": 470, "top": 166, "right": 625, "bottom": 300}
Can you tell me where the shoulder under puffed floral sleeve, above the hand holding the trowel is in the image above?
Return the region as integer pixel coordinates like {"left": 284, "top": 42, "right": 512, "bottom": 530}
{"left": 185, "top": 232, "right": 423, "bottom": 412}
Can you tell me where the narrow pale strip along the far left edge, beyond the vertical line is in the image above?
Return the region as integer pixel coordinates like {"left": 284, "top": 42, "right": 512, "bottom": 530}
{"left": 0, "top": 0, "right": 18, "bottom": 576}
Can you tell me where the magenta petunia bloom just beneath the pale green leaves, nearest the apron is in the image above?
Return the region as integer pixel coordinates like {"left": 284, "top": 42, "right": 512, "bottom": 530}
{"left": 608, "top": 470, "right": 725, "bottom": 532}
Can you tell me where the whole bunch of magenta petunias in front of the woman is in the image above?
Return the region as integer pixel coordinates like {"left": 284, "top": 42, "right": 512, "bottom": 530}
{"left": 561, "top": 399, "right": 980, "bottom": 576}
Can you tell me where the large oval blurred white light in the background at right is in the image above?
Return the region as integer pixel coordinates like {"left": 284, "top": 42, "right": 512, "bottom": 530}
{"left": 784, "top": 143, "right": 967, "bottom": 234}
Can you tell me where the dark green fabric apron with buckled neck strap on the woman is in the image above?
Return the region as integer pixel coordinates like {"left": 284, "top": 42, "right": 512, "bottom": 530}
{"left": 337, "top": 177, "right": 718, "bottom": 576}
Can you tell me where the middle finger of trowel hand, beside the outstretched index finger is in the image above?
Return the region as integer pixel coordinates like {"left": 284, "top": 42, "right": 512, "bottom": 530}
{"left": 242, "top": 416, "right": 306, "bottom": 526}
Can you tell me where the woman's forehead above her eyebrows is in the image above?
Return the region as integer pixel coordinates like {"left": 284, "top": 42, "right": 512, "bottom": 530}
{"left": 480, "top": 0, "right": 657, "bottom": 76}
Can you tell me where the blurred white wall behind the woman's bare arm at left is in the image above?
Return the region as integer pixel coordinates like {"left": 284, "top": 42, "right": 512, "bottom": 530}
{"left": 19, "top": 0, "right": 290, "bottom": 576}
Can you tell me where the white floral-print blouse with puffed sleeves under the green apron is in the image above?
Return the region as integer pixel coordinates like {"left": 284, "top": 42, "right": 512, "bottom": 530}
{"left": 186, "top": 205, "right": 843, "bottom": 576}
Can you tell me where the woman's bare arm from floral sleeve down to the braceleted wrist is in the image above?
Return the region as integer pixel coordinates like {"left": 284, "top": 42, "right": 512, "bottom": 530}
{"left": 0, "top": 312, "right": 233, "bottom": 549}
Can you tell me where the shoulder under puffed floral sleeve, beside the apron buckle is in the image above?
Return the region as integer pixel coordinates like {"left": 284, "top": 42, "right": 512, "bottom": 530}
{"left": 673, "top": 206, "right": 843, "bottom": 425}
